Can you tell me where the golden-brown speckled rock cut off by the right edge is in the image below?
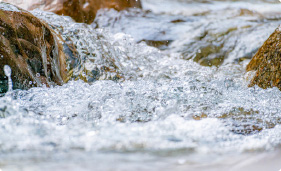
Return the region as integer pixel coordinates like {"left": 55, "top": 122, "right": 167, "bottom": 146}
{"left": 246, "top": 27, "right": 281, "bottom": 90}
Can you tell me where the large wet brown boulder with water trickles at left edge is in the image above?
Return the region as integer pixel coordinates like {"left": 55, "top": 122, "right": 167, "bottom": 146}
{"left": 0, "top": 3, "right": 74, "bottom": 93}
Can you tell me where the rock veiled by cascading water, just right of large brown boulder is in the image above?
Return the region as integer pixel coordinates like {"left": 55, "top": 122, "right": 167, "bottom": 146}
{"left": 32, "top": 10, "right": 124, "bottom": 83}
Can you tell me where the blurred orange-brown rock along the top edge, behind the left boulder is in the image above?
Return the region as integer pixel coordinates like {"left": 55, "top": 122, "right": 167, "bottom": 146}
{"left": 1, "top": 0, "right": 141, "bottom": 23}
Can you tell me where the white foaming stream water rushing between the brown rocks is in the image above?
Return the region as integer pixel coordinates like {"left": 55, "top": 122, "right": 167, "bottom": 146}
{"left": 0, "top": 0, "right": 281, "bottom": 170}
